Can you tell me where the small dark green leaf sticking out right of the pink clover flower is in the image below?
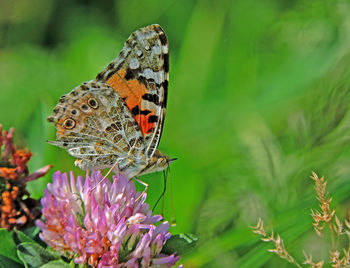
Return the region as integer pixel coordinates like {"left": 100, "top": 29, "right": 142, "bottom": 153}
{"left": 162, "top": 234, "right": 198, "bottom": 255}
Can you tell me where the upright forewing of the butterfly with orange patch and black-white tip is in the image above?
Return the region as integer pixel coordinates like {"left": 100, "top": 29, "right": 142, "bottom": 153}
{"left": 96, "top": 25, "right": 169, "bottom": 158}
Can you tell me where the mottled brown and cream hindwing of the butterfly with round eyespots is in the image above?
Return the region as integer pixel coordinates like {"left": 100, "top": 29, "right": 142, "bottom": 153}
{"left": 48, "top": 81, "right": 145, "bottom": 170}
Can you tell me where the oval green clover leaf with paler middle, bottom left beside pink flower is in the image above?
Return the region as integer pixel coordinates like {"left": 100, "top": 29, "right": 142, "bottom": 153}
{"left": 17, "top": 242, "right": 58, "bottom": 267}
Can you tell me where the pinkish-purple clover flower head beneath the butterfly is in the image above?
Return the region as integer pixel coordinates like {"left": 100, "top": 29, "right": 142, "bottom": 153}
{"left": 36, "top": 171, "right": 179, "bottom": 267}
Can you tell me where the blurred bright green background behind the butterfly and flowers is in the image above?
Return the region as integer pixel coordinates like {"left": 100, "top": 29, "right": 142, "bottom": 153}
{"left": 0, "top": 0, "right": 350, "bottom": 267}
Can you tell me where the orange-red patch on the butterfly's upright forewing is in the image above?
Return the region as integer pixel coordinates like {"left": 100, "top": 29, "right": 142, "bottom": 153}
{"left": 107, "top": 69, "right": 156, "bottom": 135}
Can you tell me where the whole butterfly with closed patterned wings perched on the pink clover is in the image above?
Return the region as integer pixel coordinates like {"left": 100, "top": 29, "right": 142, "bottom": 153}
{"left": 47, "top": 24, "right": 171, "bottom": 178}
